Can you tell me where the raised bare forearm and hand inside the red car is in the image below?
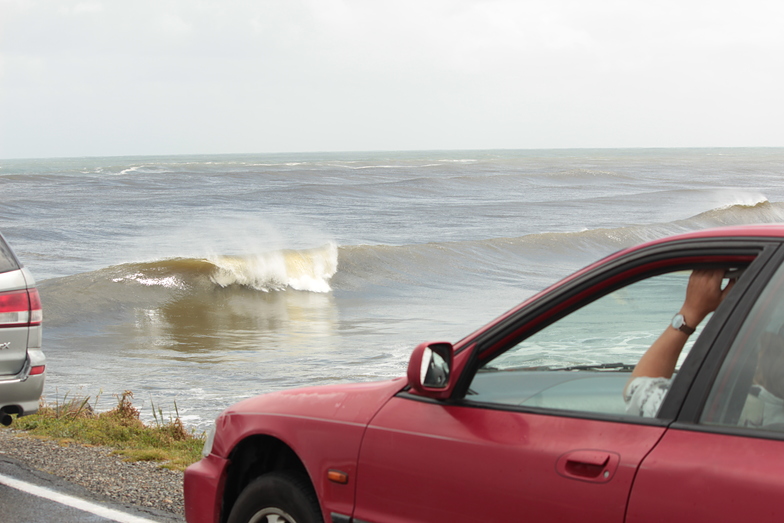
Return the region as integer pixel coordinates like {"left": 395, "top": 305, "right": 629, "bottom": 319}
{"left": 627, "top": 269, "right": 734, "bottom": 386}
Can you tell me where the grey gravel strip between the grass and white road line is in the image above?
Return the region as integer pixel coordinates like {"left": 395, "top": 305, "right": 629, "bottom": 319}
{"left": 0, "top": 428, "right": 184, "bottom": 521}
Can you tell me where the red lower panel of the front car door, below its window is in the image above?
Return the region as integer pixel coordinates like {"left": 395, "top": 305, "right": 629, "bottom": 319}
{"left": 354, "top": 398, "right": 664, "bottom": 523}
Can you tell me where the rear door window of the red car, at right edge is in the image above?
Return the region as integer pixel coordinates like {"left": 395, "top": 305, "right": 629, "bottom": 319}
{"left": 700, "top": 265, "right": 784, "bottom": 431}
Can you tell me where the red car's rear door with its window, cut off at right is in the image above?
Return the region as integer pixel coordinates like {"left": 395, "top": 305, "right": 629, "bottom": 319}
{"left": 627, "top": 247, "right": 784, "bottom": 523}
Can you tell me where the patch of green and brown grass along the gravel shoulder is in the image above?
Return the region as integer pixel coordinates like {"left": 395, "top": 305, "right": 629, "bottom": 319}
{"left": 3, "top": 391, "right": 204, "bottom": 470}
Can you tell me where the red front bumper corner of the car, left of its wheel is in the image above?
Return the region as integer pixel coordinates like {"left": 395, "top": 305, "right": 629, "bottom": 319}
{"left": 183, "top": 454, "right": 229, "bottom": 523}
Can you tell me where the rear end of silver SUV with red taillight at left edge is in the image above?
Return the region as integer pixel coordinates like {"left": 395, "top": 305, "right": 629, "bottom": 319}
{"left": 0, "top": 234, "right": 46, "bottom": 425}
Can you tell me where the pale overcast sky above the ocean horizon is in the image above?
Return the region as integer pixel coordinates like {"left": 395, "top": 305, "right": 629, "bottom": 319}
{"left": 0, "top": 0, "right": 784, "bottom": 158}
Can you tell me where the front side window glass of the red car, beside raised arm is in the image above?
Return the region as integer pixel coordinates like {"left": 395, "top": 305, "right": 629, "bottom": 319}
{"left": 466, "top": 271, "right": 707, "bottom": 415}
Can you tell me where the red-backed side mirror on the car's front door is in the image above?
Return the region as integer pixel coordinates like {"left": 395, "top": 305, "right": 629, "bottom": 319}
{"left": 408, "top": 342, "right": 454, "bottom": 399}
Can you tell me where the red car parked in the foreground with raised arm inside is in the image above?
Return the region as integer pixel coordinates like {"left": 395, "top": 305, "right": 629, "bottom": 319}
{"left": 185, "top": 225, "right": 784, "bottom": 523}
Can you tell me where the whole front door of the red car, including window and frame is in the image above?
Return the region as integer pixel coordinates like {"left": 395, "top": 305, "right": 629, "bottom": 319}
{"left": 353, "top": 245, "right": 761, "bottom": 523}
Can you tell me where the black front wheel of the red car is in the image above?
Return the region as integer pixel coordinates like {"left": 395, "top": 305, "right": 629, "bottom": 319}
{"left": 228, "top": 472, "right": 323, "bottom": 523}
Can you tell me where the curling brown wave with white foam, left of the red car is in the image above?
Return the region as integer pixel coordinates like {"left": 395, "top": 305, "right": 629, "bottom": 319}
{"left": 38, "top": 244, "right": 338, "bottom": 325}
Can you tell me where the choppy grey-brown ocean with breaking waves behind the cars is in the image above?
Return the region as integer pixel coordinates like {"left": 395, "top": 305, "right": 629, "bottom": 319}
{"left": 0, "top": 148, "right": 784, "bottom": 430}
